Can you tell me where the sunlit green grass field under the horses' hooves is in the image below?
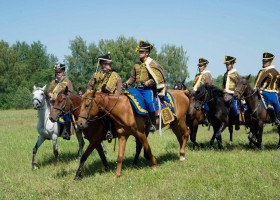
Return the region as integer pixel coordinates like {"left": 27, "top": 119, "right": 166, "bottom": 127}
{"left": 0, "top": 110, "right": 280, "bottom": 199}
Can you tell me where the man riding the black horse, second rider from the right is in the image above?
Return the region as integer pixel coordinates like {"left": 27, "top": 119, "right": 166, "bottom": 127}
{"left": 222, "top": 55, "right": 240, "bottom": 130}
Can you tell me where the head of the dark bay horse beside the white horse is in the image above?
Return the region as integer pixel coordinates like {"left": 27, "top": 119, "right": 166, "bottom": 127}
{"left": 49, "top": 86, "right": 70, "bottom": 122}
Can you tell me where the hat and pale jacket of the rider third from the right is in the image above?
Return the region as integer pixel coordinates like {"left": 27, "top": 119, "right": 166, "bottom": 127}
{"left": 192, "top": 58, "right": 213, "bottom": 92}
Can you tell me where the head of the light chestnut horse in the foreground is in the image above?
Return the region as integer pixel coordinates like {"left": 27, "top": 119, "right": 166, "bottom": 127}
{"left": 77, "top": 90, "right": 99, "bottom": 129}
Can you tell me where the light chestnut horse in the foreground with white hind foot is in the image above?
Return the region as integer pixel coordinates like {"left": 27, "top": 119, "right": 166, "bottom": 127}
{"left": 77, "top": 90, "right": 190, "bottom": 177}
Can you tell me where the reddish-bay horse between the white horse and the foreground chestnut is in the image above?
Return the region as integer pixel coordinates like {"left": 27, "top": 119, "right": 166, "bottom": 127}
{"left": 49, "top": 87, "right": 109, "bottom": 175}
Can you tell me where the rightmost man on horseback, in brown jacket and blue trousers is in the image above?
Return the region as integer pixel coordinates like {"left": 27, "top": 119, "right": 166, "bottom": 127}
{"left": 255, "top": 51, "right": 280, "bottom": 125}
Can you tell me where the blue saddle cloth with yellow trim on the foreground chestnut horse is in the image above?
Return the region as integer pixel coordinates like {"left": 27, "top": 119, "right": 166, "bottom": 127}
{"left": 125, "top": 88, "right": 177, "bottom": 119}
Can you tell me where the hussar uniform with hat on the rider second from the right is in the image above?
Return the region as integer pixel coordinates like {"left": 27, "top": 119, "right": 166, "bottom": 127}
{"left": 223, "top": 55, "right": 240, "bottom": 116}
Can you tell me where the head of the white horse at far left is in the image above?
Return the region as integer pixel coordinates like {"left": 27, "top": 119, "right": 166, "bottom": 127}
{"left": 32, "top": 85, "right": 46, "bottom": 110}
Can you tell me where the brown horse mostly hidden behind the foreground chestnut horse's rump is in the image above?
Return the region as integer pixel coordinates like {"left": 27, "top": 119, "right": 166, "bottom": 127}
{"left": 174, "top": 81, "right": 237, "bottom": 149}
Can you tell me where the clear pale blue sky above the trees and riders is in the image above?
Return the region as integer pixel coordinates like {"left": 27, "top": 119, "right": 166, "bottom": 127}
{"left": 0, "top": 0, "right": 280, "bottom": 81}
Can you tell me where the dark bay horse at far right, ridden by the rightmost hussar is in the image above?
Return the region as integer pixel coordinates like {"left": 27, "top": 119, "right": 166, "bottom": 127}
{"left": 234, "top": 75, "right": 280, "bottom": 149}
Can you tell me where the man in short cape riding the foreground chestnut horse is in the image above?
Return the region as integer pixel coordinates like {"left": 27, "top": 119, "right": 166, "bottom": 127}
{"left": 122, "top": 39, "right": 166, "bottom": 132}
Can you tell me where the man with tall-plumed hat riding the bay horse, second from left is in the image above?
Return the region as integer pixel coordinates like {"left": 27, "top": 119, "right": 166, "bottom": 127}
{"left": 87, "top": 52, "right": 122, "bottom": 143}
